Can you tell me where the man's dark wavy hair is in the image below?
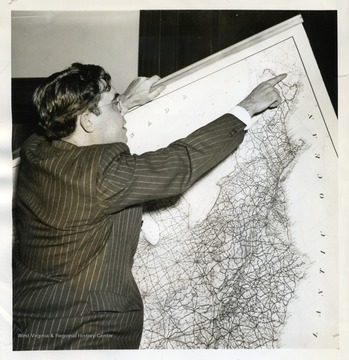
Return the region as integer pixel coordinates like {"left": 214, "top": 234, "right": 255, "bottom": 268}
{"left": 33, "top": 63, "right": 111, "bottom": 140}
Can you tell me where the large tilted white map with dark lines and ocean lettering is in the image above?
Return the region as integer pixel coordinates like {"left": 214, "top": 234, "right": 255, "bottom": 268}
{"left": 127, "top": 17, "right": 338, "bottom": 349}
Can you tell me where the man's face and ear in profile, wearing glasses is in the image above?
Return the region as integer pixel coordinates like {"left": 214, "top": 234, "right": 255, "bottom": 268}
{"left": 92, "top": 87, "right": 127, "bottom": 144}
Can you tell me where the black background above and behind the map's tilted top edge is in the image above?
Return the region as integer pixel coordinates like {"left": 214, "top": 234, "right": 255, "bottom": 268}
{"left": 138, "top": 10, "right": 338, "bottom": 112}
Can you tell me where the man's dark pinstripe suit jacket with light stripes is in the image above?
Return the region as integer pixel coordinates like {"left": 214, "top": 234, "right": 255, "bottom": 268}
{"left": 13, "top": 114, "right": 245, "bottom": 350}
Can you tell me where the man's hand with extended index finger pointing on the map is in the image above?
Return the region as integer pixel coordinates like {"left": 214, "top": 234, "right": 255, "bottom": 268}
{"left": 238, "top": 74, "right": 287, "bottom": 117}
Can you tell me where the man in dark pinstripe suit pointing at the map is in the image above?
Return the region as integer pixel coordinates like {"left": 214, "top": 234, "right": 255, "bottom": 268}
{"left": 13, "top": 63, "right": 285, "bottom": 350}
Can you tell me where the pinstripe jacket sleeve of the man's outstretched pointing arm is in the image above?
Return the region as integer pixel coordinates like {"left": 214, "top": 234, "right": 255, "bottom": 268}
{"left": 97, "top": 114, "right": 246, "bottom": 212}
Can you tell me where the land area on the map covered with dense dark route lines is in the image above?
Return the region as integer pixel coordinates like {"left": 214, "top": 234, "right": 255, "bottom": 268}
{"left": 133, "top": 78, "right": 307, "bottom": 349}
